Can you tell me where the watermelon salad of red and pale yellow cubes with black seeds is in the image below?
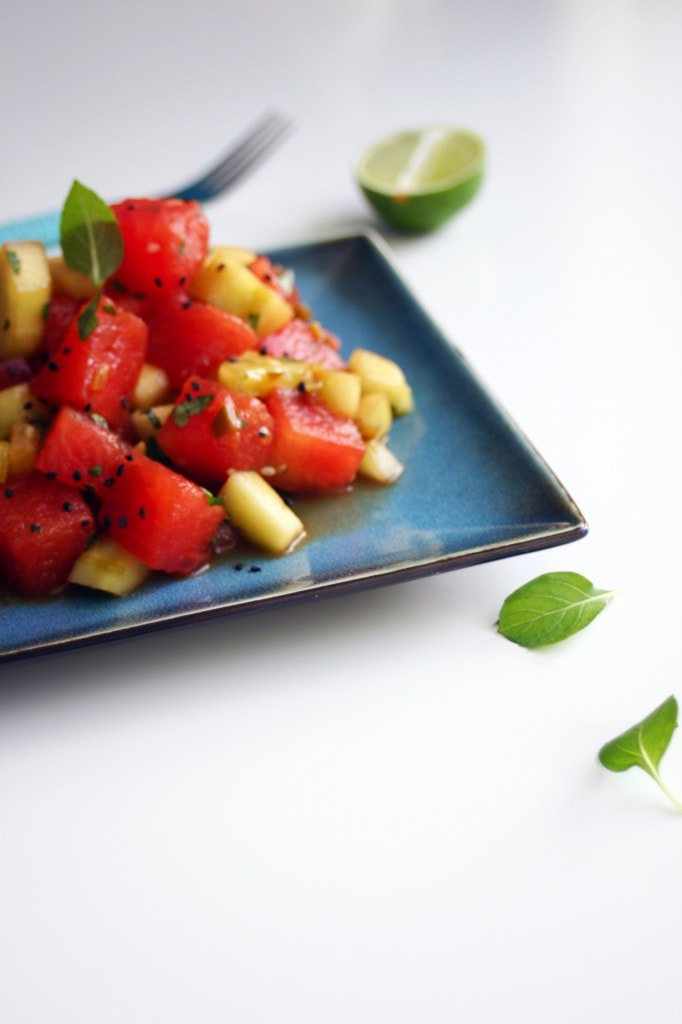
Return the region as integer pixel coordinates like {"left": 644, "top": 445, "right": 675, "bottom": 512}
{"left": 0, "top": 190, "right": 413, "bottom": 597}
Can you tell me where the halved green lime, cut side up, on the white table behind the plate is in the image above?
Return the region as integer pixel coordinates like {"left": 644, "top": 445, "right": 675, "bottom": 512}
{"left": 355, "top": 125, "right": 485, "bottom": 231}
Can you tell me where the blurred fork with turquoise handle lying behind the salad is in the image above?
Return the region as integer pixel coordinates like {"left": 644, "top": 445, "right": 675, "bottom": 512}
{"left": 0, "top": 114, "right": 293, "bottom": 248}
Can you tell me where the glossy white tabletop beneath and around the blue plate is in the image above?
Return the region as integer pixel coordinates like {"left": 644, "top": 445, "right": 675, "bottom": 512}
{"left": 0, "top": 0, "right": 682, "bottom": 1024}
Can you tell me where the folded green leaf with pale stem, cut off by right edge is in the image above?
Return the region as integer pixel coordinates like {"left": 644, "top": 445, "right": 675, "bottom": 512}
{"left": 599, "top": 696, "right": 682, "bottom": 811}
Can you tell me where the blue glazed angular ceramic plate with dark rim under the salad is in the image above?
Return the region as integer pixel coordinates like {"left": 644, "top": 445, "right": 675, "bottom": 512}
{"left": 0, "top": 234, "right": 587, "bottom": 658}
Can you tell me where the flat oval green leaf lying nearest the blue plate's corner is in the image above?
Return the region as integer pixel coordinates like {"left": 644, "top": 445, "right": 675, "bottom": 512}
{"left": 498, "top": 572, "right": 613, "bottom": 647}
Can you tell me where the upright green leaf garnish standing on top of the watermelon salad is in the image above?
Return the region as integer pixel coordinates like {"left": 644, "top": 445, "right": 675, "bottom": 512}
{"left": 60, "top": 181, "right": 123, "bottom": 288}
